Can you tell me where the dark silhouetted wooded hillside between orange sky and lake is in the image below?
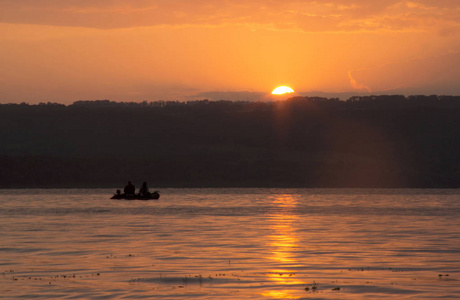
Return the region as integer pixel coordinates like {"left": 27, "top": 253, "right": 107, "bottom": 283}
{"left": 0, "top": 95, "right": 460, "bottom": 188}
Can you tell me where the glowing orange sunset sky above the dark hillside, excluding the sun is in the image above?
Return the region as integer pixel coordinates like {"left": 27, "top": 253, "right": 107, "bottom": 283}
{"left": 0, "top": 0, "right": 460, "bottom": 104}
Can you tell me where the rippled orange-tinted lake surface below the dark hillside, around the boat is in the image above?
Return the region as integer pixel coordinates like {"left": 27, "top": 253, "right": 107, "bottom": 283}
{"left": 0, "top": 189, "right": 460, "bottom": 299}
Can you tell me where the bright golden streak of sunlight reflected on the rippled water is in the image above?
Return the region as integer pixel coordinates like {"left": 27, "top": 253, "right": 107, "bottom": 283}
{"left": 261, "top": 194, "right": 304, "bottom": 299}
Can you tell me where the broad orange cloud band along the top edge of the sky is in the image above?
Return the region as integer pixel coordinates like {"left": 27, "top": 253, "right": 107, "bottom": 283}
{"left": 0, "top": 0, "right": 460, "bottom": 32}
